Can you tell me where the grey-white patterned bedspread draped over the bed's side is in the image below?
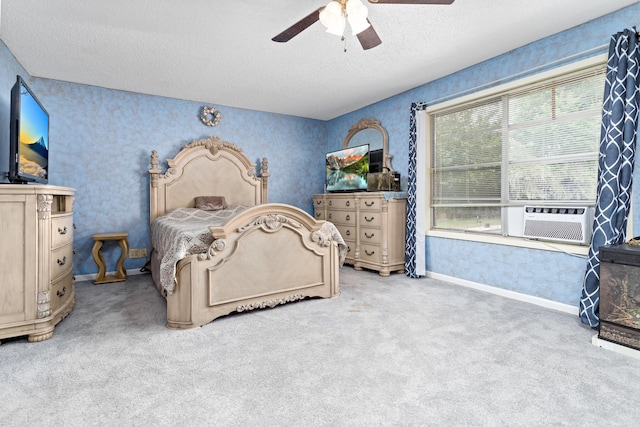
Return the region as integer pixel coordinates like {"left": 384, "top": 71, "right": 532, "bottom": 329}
{"left": 151, "top": 205, "right": 248, "bottom": 294}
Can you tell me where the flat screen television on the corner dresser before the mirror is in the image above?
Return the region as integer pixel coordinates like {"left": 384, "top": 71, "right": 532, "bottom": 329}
{"left": 325, "top": 144, "right": 369, "bottom": 193}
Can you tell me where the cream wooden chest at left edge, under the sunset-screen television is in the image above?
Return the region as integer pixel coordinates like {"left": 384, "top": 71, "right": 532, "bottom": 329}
{"left": 0, "top": 184, "right": 75, "bottom": 342}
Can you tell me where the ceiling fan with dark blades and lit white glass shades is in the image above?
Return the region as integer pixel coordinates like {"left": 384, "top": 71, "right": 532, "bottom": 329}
{"left": 271, "top": 0, "right": 455, "bottom": 50}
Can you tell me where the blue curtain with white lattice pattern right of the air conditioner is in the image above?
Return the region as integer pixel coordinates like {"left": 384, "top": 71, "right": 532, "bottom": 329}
{"left": 580, "top": 28, "right": 640, "bottom": 327}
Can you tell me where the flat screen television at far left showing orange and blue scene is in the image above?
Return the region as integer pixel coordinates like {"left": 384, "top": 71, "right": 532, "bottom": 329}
{"left": 9, "top": 76, "right": 49, "bottom": 184}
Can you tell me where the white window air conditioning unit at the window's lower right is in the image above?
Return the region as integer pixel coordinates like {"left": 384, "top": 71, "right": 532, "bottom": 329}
{"left": 522, "top": 206, "right": 593, "bottom": 245}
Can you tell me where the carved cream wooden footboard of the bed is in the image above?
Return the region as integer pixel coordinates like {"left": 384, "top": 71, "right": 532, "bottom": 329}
{"left": 162, "top": 204, "right": 340, "bottom": 329}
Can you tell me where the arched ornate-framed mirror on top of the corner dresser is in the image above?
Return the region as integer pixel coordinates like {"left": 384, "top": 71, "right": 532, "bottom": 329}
{"left": 342, "top": 119, "right": 393, "bottom": 172}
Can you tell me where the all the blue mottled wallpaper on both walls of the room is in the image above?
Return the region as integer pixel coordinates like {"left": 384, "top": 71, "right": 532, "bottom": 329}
{"left": 0, "top": 4, "right": 640, "bottom": 305}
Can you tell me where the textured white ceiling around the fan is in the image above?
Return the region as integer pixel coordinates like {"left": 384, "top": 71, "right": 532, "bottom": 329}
{"left": 0, "top": 0, "right": 638, "bottom": 120}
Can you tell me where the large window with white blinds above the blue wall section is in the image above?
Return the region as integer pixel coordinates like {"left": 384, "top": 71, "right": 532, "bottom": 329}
{"left": 429, "top": 64, "right": 606, "bottom": 234}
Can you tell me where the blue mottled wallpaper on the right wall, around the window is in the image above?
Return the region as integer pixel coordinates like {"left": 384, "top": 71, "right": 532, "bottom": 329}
{"left": 327, "top": 4, "right": 640, "bottom": 310}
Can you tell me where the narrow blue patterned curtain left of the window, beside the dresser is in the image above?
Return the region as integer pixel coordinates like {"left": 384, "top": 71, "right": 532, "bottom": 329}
{"left": 404, "top": 103, "right": 427, "bottom": 278}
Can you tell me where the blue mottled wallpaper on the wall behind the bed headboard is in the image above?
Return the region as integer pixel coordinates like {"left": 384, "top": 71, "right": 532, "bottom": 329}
{"left": 0, "top": 44, "right": 327, "bottom": 274}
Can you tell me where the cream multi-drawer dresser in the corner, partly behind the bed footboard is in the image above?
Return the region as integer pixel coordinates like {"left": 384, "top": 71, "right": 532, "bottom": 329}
{"left": 313, "top": 192, "right": 407, "bottom": 276}
